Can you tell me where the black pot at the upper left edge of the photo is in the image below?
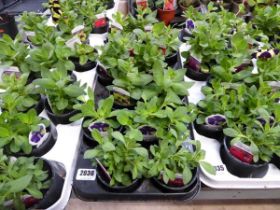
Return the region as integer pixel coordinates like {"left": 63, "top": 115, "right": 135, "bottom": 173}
{"left": 0, "top": 14, "right": 18, "bottom": 39}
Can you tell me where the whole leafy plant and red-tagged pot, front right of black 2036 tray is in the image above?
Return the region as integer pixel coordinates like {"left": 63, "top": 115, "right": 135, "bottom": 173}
{"left": 148, "top": 139, "right": 215, "bottom": 193}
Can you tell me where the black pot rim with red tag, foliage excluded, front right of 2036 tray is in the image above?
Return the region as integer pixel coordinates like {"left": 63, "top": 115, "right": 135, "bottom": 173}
{"left": 151, "top": 168, "right": 198, "bottom": 193}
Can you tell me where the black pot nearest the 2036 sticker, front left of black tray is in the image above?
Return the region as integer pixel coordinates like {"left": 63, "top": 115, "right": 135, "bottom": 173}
{"left": 97, "top": 166, "right": 143, "bottom": 193}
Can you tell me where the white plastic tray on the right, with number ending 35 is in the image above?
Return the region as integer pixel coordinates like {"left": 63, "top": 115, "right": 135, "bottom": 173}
{"left": 180, "top": 44, "right": 280, "bottom": 189}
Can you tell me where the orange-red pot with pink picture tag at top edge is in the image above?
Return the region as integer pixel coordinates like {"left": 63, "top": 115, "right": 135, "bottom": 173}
{"left": 156, "top": 0, "right": 176, "bottom": 25}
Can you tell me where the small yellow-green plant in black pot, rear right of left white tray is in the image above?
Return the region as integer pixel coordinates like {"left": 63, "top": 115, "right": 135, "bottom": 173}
{"left": 69, "top": 43, "right": 97, "bottom": 72}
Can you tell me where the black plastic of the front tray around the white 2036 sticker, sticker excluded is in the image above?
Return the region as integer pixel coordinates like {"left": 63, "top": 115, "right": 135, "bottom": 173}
{"left": 73, "top": 130, "right": 201, "bottom": 201}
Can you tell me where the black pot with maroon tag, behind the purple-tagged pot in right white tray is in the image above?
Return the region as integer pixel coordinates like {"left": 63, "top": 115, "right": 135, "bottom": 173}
{"left": 184, "top": 56, "right": 210, "bottom": 81}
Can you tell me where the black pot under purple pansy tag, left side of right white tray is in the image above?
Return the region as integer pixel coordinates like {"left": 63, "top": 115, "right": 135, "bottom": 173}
{"left": 193, "top": 120, "right": 224, "bottom": 143}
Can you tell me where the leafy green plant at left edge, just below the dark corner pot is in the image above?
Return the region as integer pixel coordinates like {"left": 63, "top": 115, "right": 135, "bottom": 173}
{"left": 0, "top": 34, "right": 30, "bottom": 73}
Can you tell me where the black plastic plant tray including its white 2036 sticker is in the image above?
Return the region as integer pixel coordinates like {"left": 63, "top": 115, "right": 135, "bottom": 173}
{"left": 73, "top": 76, "right": 201, "bottom": 201}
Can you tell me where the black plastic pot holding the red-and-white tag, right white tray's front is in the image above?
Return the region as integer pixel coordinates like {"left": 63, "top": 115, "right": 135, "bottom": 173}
{"left": 220, "top": 137, "right": 268, "bottom": 178}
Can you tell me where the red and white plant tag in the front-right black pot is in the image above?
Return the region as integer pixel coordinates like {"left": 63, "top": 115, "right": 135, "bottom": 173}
{"left": 229, "top": 142, "right": 254, "bottom": 164}
